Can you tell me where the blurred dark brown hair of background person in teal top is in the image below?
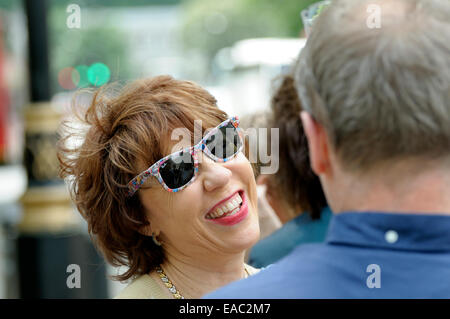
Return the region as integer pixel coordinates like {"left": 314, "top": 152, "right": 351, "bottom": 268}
{"left": 269, "top": 73, "right": 327, "bottom": 219}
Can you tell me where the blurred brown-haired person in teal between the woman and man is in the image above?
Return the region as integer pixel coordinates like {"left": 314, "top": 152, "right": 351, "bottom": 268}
{"left": 248, "top": 71, "right": 332, "bottom": 268}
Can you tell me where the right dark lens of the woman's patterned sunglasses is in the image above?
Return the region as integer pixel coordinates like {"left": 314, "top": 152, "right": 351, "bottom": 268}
{"left": 206, "top": 122, "right": 241, "bottom": 159}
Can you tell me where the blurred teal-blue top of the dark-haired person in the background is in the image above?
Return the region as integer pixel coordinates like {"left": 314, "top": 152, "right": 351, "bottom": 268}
{"left": 248, "top": 207, "right": 333, "bottom": 268}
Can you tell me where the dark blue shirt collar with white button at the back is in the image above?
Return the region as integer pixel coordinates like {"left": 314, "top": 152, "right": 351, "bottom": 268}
{"left": 326, "top": 212, "right": 450, "bottom": 251}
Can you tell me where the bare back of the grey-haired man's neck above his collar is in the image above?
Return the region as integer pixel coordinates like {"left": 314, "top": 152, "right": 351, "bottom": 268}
{"left": 332, "top": 161, "right": 450, "bottom": 215}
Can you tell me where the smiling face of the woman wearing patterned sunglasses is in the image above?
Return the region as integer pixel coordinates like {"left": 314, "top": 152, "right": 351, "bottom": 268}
{"left": 139, "top": 134, "right": 259, "bottom": 258}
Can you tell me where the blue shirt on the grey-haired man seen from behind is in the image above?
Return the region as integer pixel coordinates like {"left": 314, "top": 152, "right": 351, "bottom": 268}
{"left": 207, "top": 212, "right": 450, "bottom": 299}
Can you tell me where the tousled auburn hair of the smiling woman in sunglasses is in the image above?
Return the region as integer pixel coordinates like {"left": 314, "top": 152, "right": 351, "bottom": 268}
{"left": 57, "top": 76, "right": 228, "bottom": 280}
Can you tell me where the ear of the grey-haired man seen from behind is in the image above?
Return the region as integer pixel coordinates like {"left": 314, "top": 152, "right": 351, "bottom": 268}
{"left": 300, "top": 111, "right": 330, "bottom": 175}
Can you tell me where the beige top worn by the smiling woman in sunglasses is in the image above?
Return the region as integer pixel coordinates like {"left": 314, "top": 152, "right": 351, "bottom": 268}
{"left": 114, "top": 264, "right": 259, "bottom": 299}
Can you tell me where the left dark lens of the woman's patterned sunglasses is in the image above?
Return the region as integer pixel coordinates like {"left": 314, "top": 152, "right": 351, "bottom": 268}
{"left": 159, "top": 152, "right": 194, "bottom": 189}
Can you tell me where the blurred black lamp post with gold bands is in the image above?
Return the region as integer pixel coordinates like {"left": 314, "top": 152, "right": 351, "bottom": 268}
{"left": 17, "top": 0, "right": 107, "bottom": 298}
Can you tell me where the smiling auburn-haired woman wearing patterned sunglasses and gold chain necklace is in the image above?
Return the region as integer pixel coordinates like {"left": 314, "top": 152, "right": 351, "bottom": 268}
{"left": 58, "top": 76, "right": 259, "bottom": 299}
